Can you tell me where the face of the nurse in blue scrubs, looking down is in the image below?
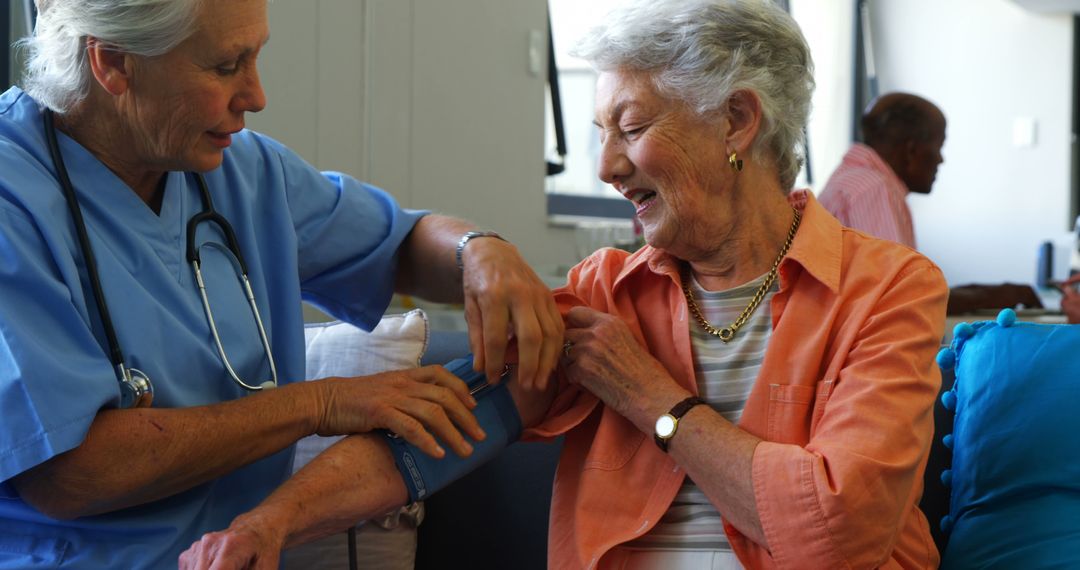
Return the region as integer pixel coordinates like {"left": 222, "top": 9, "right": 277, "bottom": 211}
{"left": 118, "top": 0, "right": 269, "bottom": 172}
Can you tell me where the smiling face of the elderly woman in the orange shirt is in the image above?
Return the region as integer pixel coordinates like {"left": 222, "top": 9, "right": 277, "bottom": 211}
{"left": 595, "top": 70, "right": 731, "bottom": 253}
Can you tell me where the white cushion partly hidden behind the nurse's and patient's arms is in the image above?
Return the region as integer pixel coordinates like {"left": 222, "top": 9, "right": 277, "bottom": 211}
{"left": 282, "top": 309, "right": 428, "bottom": 570}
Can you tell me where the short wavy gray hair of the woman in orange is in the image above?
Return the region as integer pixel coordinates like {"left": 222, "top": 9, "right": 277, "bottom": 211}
{"left": 571, "top": 0, "right": 814, "bottom": 192}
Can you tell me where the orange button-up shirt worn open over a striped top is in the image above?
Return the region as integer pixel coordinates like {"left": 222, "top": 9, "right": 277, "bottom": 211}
{"left": 528, "top": 191, "right": 948, "bottom": 570}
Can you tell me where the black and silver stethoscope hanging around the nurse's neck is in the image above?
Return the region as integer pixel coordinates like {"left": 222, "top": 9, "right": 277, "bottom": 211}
{"left": 44, "top": 109, "right": 278, "bottom": 408}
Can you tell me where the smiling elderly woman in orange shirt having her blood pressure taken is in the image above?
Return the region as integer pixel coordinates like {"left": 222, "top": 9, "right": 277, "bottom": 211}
{"left": 190, "top": 0, "right": 946, "bottom": 569}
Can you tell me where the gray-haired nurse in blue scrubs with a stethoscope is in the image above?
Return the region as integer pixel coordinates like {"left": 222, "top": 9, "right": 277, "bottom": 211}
{"left": 0, "top": 0, "right": 563, "bottom": 568}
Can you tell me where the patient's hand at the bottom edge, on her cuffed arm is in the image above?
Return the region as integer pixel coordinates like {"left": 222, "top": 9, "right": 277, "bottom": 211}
{"left": 179, "top": 516, "right": 284, "bottom": 570}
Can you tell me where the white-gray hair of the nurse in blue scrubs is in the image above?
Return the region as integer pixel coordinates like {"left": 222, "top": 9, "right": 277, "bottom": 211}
{"left": 18, "top": 0, "right": 202, "bottom": 113}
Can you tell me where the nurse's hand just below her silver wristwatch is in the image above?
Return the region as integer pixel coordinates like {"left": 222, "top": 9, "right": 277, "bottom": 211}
{"left": 461, "top": 238, "right": 563, "bottom": 389}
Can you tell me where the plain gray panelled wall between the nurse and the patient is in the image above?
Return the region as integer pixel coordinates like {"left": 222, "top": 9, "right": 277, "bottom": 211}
{"left": 248, "top": 0, "right": 575, "bottom": 274}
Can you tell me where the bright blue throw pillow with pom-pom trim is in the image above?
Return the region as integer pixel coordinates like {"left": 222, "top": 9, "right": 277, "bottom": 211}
{"left": 937, "top": 309, "right": 1080, "bottom": 569}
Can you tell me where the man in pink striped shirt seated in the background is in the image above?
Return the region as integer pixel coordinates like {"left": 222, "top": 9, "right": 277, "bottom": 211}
{"left": 820, "top": 93, "right": 1042, "bottom": 314}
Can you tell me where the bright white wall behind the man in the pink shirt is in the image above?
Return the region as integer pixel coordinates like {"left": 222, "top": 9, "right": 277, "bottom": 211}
{"left": 872, "top": 0, "right": 1072, "bottom": 284}
